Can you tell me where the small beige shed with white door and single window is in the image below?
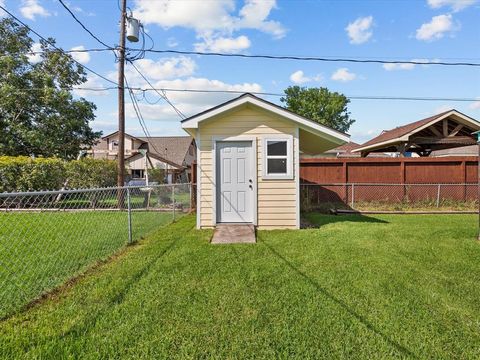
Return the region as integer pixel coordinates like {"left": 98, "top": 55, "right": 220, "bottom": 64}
{"left": 182, "top": 94, "right": 349, "bottom": 229}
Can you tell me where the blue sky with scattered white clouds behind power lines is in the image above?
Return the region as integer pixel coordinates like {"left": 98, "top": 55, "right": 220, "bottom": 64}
{"left": 0, "top": 0, "right": 480, "bottom": 143}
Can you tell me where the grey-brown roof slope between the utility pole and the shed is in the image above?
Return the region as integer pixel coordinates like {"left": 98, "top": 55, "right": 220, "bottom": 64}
{"left": 139, "top": 136, "right": 193, "bottom": 165}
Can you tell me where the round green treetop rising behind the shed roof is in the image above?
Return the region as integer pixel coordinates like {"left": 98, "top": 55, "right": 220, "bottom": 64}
{"left": 280, "top": 86, "right": 355, "bottom": 132}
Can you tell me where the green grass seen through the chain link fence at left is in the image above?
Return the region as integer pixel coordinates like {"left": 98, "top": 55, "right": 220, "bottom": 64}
{"left": 0, "top": 211, "right": 177, "bottom": 318}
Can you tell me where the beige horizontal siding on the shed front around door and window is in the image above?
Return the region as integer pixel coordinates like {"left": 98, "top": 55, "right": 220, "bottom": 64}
{"left": 197, "top": 107, "right": 298, "bottom": 229}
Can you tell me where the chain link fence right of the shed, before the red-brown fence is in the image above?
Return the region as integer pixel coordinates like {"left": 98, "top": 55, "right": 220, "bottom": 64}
{"left": 300, "top": 183, "right": 478, "bottom": 212}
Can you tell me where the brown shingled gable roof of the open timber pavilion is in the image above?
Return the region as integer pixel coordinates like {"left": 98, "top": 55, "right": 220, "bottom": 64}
{"left": 353, "top": 109, "right": 480, "bottom": 152}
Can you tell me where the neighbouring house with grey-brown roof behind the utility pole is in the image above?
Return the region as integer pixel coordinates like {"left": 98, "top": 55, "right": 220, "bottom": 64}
{"left": 87, "top": 131, "right": 195, "bottom": 183}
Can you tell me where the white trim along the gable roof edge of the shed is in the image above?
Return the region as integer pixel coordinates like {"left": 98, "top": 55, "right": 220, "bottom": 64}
{"left": 182, "top": 95, "right": 350, "bottom": 142}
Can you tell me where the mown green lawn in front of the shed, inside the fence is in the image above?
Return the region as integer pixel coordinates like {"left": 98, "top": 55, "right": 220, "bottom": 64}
{"left": 0, "top": 215, "right": 480, "bottom": 359}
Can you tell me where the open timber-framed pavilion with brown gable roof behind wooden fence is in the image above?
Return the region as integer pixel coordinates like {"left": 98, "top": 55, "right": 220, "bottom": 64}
{"left": 353, "top": 110, "right": 480, "bottom": 157}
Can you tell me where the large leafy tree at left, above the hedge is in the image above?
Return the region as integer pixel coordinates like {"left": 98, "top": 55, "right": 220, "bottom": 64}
{"left": 0, "top": 18, "right": 101, "bottom": 159}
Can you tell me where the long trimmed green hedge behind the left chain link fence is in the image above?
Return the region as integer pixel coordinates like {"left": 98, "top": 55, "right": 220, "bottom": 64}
{"left": 0, "top": 156, "right": 117, "bottom": 192}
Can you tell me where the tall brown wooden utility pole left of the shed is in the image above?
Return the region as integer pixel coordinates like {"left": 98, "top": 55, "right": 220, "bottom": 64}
{"left": 117, "top": 0, "right": 127, "bottom": 187}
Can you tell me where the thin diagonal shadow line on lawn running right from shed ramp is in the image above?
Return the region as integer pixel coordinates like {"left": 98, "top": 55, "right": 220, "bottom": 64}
{"left": 263, "top": 243, "right": 417, "bottom": 358}
